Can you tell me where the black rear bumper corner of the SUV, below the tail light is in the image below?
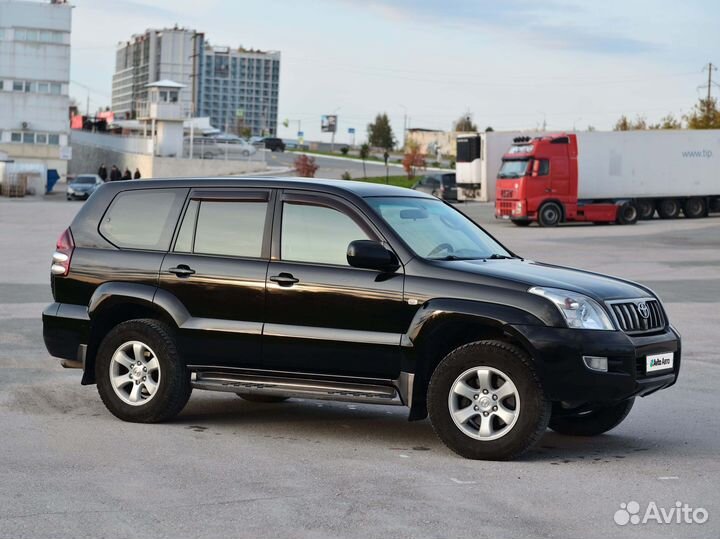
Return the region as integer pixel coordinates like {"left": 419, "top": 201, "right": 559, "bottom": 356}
{"left": 43, "top": 303, "right": 90, "bottom": 360}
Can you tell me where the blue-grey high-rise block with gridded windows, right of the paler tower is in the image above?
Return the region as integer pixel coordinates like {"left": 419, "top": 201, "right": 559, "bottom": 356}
{"left": 194, "top": 36, "right": 280, "bottom": 135}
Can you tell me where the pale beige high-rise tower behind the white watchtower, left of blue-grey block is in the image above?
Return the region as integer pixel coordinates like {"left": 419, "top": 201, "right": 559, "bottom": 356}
{"left": 112, "top": 27, "right": 197, "bottom": 120}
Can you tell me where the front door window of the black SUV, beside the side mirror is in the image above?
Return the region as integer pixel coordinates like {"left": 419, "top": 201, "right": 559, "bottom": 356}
{"left": 280, "top": 203, "right": 368, "bottom": 266}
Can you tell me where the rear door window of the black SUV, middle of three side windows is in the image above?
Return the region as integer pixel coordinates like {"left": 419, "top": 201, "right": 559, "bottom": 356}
{"left": 194, "top": 200, "right": 267, "bottom": 258}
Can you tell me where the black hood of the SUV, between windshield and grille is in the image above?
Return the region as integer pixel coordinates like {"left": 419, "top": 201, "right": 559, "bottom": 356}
{"left": 442, "top": 259, "right": 654, "bottom": 301}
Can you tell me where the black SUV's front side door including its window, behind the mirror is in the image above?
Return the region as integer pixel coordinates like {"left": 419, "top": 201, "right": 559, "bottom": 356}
{"left": 263, "top": 190, "right": 406, "bottom": 379}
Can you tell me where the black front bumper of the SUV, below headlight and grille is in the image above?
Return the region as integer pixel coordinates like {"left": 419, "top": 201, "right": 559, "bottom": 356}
{"left": 512, "top": 325, "right": 681, "bottom": 402}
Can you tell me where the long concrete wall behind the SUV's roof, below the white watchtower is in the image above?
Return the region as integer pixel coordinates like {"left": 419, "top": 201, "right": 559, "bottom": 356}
{"left": 68, "top": 143, "right": 267, "bottom": 178}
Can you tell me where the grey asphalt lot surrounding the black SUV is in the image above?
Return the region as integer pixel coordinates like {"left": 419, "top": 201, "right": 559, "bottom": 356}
{"left": 0, "top": 195, "right": 720, "bottom": 539}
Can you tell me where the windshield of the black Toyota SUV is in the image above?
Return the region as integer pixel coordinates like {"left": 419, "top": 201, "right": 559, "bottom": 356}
{"left": 366, "top": 197, "right": 512, "bottom": 260}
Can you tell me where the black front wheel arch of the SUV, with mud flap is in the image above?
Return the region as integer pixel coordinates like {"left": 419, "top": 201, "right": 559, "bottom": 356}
{"left": 403, "top": 300, "right": 545, "bottom": 421}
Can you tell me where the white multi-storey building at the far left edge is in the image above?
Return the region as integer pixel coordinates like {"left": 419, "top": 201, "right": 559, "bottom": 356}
{"left": 0, "top": 0, "right": 72, "bottom": 181}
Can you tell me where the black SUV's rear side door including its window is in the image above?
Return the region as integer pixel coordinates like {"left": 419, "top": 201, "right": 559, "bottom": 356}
{"left": 159, "top": 188, "right": 273, "bottom": 367}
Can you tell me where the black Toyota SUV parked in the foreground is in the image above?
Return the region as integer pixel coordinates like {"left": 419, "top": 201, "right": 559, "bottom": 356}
{"left": 43, "top": 178, "right": 680, "bottom": 459}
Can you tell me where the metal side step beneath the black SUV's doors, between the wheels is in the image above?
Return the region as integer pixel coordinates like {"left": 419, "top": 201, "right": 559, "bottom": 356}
{"left": 190, "top": 372, "right": 403, "bottom": 405}
